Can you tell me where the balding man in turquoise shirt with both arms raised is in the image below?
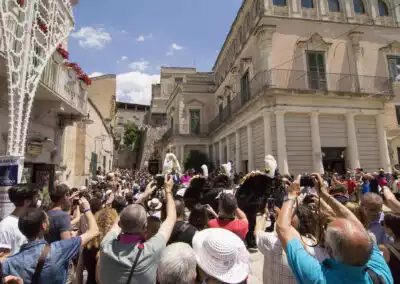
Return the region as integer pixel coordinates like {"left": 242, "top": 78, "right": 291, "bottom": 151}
{"left": 277, "top": 174, "right": 393, "bottom": 284}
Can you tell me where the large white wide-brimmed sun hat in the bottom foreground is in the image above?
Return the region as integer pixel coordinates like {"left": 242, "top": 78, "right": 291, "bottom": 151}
{"left": 193, "top": 228, "right": 250, "bottom": 284}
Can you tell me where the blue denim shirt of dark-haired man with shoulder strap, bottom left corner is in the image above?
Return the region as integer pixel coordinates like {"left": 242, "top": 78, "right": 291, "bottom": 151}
{"left": 3, "top": 237, "right": 81, "bottom": 284}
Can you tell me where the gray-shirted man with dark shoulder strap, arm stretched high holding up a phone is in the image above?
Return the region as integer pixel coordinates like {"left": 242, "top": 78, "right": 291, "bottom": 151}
{"left": 99, "top": 178, "right": 176, "bottom": 284}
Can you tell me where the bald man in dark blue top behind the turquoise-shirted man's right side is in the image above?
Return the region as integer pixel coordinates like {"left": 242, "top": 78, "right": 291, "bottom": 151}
{"left": 361, "top": 192, "right": 393, "bottom": 245}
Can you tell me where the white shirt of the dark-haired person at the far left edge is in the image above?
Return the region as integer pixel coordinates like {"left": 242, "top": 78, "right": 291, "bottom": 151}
{"left": 0, "top": 215, "right": 27, "bottom": 255}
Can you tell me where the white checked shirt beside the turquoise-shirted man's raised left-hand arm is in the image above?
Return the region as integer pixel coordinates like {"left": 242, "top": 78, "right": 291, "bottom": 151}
{"left": 257, "top": 232, "right": 329, "bottom": 284}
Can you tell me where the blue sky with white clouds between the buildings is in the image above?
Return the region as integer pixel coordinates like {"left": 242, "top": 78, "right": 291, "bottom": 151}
{"left": 68, "top": 0, "right": 242, "bottom": 104}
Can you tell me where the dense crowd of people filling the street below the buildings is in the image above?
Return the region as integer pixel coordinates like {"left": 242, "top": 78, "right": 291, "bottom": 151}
{"left": 0, "top": 153, "right": 400, "bottom": 284}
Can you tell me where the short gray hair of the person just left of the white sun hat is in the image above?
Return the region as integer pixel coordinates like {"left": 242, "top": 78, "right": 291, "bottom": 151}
{"left": 157, "top": 243, "right": 196, "bottom": 284}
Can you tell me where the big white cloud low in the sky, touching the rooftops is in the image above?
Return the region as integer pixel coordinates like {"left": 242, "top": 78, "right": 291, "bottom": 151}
{"left": 117, "top": 71, "right": 160, "bottom": 105}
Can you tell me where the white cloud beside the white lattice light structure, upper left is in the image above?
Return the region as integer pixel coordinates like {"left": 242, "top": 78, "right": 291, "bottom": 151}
{"left": 71, "top": 27, "right": 112, "bottom": 49}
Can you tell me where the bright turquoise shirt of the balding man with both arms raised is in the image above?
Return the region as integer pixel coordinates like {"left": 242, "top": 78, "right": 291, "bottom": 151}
{"left": 286, "top": 239, "right": 393, "bottom": 284}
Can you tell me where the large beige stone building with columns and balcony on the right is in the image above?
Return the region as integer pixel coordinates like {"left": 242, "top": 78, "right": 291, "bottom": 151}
{"left": 160, "top": 0, "right": 400, "bottom": 174}
